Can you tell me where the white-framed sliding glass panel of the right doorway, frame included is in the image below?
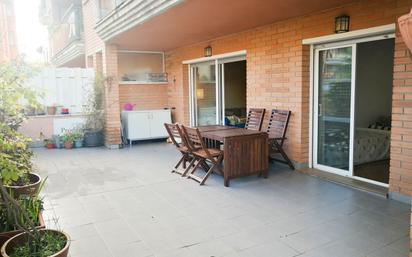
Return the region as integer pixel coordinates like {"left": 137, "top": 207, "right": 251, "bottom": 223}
{"left": 314, "top": 45, "right": 356, "bottom": 176}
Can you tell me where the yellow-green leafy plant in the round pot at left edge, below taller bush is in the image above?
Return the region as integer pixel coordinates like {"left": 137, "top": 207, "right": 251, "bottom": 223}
{"left": 0, "top": 123, "right": 33, "bottom": 185}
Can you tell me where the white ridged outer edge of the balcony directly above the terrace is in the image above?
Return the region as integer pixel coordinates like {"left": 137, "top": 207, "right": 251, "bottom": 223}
{"left": 95, "top": 0, "right": 183, "bottom": 41}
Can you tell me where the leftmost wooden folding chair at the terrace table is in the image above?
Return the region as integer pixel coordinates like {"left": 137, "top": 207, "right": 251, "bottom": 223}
{"left": 164, "top": 123, "right": 194, "bottom": 176}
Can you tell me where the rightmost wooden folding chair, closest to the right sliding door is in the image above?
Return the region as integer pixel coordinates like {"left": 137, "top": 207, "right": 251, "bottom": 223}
{"left": 266, "top": 109, "right": 295, "bottom": 170}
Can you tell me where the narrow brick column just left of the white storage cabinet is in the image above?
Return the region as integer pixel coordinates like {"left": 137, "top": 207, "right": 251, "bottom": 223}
{"left": 102, "top": 45, "right": 121, "bottom": 148}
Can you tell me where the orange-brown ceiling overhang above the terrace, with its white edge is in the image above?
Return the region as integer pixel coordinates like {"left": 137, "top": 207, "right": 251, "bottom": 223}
{"left": 96, "top": 0, "right": 353, "bottom": 51}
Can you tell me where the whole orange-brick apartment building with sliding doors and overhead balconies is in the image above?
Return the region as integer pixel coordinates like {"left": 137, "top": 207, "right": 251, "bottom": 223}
{"left": 42, "top": 0, "right": 412, "bottom": 206}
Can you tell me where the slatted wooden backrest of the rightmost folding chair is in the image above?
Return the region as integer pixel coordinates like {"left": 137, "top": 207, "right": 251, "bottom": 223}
{"left": 267, "top": 109, "right": 292, "bottom": 144}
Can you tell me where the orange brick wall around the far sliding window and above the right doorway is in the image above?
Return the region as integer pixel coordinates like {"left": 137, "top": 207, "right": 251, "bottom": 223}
{"left": 166, "top": 0, "right": 412, "bottom": 171}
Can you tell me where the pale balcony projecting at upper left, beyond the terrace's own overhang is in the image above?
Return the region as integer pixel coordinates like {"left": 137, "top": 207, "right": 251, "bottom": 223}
{"left": 51, "top": 5, "right": 84, "bottom": 67}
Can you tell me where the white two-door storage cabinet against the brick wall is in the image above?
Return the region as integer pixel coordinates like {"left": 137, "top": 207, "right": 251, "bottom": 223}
{"left": 122, "top": 110, "right": 172, "bottom": 146}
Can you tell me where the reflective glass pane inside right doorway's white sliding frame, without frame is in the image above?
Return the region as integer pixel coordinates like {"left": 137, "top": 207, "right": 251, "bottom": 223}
{"left": 317, "top": 47, "right": 352, "bottom": 170}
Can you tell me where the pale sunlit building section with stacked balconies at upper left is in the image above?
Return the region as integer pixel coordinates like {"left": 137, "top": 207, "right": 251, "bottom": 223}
{"left": 40, "top": 0, "right": 85, "bottom": 68}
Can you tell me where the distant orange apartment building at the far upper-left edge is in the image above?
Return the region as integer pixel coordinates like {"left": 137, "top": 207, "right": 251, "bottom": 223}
{"left": 0, "top": 0, "right": 18, "bottom": 63}
